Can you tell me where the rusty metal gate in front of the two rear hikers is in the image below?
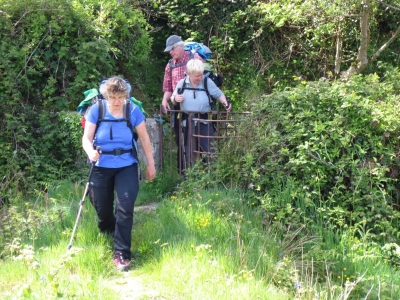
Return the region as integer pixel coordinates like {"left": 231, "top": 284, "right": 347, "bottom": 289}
{"left": 160, "top": 106, "right": 250, "bottom": 176}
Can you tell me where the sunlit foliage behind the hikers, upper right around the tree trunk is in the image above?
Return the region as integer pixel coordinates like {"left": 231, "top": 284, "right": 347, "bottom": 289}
{"left": 144, "top": 0, "right": 400, "bottom": 99}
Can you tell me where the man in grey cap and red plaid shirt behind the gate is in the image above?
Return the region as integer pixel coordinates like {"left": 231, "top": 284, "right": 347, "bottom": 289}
{"left": 161, "top": 35, "right": 204, "bottom": 173}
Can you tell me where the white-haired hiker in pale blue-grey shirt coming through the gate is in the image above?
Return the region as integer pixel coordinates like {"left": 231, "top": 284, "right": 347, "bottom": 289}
{"left": 171, "top": 59, "right": 231, "bottom": 170}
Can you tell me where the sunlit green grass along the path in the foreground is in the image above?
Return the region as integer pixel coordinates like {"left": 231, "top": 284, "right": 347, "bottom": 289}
{"left": 0, "top": 176, "right": 400, "bottom": 300}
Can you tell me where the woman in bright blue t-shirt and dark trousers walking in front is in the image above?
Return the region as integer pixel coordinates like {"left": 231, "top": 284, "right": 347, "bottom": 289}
{"left": 82, "top": 77, "right": 156, "bottom": 271}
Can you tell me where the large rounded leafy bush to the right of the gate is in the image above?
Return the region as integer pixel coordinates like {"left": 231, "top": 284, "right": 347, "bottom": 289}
{"left": 218, "top": 75, "right": 400, "bottom": 241}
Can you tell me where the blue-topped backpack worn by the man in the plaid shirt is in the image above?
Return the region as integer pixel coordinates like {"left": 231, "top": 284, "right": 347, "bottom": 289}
{"left": 168, "top": 42, "right": 224, "bottom": 87}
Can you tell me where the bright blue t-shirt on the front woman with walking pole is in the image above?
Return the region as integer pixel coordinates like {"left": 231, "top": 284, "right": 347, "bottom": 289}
{"left": 86, "top": 100, "right": 145, "bottom": 168}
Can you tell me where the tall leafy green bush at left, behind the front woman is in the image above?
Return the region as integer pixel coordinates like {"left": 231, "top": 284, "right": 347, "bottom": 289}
{"left": 0, "top": 0, "right": 151, "bottom": 196}
